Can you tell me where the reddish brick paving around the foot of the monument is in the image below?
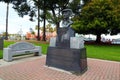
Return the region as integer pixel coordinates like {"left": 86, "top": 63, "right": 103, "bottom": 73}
{"left": 0, "top": 57, "right": 120, "bottom": 80}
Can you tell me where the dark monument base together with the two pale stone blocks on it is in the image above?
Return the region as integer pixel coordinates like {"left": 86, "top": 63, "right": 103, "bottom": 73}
{"left": 46, "top": 37, "right": 87, "bottom": 73}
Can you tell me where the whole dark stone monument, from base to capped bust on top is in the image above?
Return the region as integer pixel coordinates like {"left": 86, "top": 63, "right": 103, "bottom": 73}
{"left": 46, "top": 9, "right": 87, "bottom": 73}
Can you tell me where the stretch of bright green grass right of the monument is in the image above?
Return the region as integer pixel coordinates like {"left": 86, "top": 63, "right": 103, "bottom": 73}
{"left": 86, "top": 45, "right": 120, "bottom": 61}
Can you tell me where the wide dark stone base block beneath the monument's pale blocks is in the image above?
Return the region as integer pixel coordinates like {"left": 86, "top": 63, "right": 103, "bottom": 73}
{"left": 46, "top": 47, "right": 87, "bottom": 73}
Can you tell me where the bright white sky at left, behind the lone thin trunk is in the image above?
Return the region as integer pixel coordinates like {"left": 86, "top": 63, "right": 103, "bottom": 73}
{"left": 0, "top": 2, "right": 37, "bottom": 34}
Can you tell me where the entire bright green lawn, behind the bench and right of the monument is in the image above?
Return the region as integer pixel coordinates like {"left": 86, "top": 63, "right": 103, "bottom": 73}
{"left": 0, "top": 41, "right": 120, "bottom": 61}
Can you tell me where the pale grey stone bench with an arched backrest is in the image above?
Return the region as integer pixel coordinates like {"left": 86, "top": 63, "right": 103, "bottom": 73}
{"left": 3, "top": 42, "right": 41, "bottom": 61}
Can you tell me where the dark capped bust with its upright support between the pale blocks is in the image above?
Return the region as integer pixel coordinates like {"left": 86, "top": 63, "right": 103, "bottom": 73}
{"left": 56, "top": 9, "right": 75, "bottom": 48}
